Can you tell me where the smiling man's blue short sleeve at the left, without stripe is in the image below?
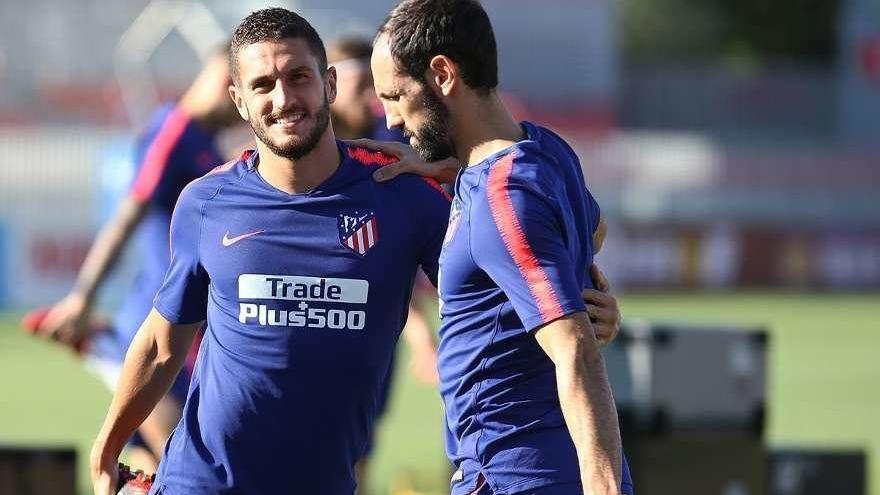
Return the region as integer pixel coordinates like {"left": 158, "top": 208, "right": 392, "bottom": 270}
{"left": 153, "top": 186, "right": 209, "bottom": 324}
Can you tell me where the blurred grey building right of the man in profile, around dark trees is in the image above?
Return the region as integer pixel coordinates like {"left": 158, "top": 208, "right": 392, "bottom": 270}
{"left": 579, "top": 0, "right": 880, "bottom": 289}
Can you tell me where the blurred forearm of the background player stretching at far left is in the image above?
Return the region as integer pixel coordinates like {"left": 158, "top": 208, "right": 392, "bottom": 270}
{"left": 73, "top": 198, "right": 146, "bottom": 302}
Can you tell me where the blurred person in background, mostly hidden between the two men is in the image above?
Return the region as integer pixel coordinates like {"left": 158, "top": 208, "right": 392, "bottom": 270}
{"left": 327, "top": 36, "right": 439, "bottom": 493}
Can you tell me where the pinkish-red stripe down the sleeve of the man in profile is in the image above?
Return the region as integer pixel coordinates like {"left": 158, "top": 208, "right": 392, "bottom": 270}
{"left": 487, "top": 154, "right": 562, "bottom": 321}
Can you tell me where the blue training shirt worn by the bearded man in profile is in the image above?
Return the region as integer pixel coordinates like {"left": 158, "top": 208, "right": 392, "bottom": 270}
{"left": 438, "top": 122, "right": 632, "bottom": 495}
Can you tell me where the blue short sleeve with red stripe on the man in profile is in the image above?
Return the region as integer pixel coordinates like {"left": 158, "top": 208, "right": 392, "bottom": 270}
{"left": 470, "top": 155, "right": 586, "bottom": 331}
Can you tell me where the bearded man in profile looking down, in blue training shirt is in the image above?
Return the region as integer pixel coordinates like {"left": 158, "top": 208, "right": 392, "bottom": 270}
{"left": 371, "top": 0, "right": 632, "bottom": 495}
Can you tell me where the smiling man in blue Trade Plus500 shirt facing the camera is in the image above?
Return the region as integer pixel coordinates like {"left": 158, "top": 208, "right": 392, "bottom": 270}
{"left": 92, "top": 9, "right": 449, "bottom": 495}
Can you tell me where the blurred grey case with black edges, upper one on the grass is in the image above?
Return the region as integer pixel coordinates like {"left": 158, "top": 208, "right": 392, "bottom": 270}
{"left": 604, "top": 322, "right": 768, "bottom": 439}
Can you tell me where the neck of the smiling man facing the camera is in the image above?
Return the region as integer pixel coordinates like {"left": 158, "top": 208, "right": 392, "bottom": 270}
{"left": 257, "top": 126, "right": 342, "bottom": 194}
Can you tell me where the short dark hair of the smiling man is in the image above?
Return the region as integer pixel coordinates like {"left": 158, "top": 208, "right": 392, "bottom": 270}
{"left": 229, "top": 7, "right": 327, "bottom": 82}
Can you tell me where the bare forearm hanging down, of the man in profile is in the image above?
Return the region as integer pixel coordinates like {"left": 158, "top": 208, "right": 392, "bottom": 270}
{"left": 556, "top": 349, "right": 622, "bottom": 494}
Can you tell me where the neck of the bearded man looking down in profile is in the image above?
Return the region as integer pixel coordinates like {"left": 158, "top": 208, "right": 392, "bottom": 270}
{"left": 451, "top": 91, "right": 525, "bottom": 166}
